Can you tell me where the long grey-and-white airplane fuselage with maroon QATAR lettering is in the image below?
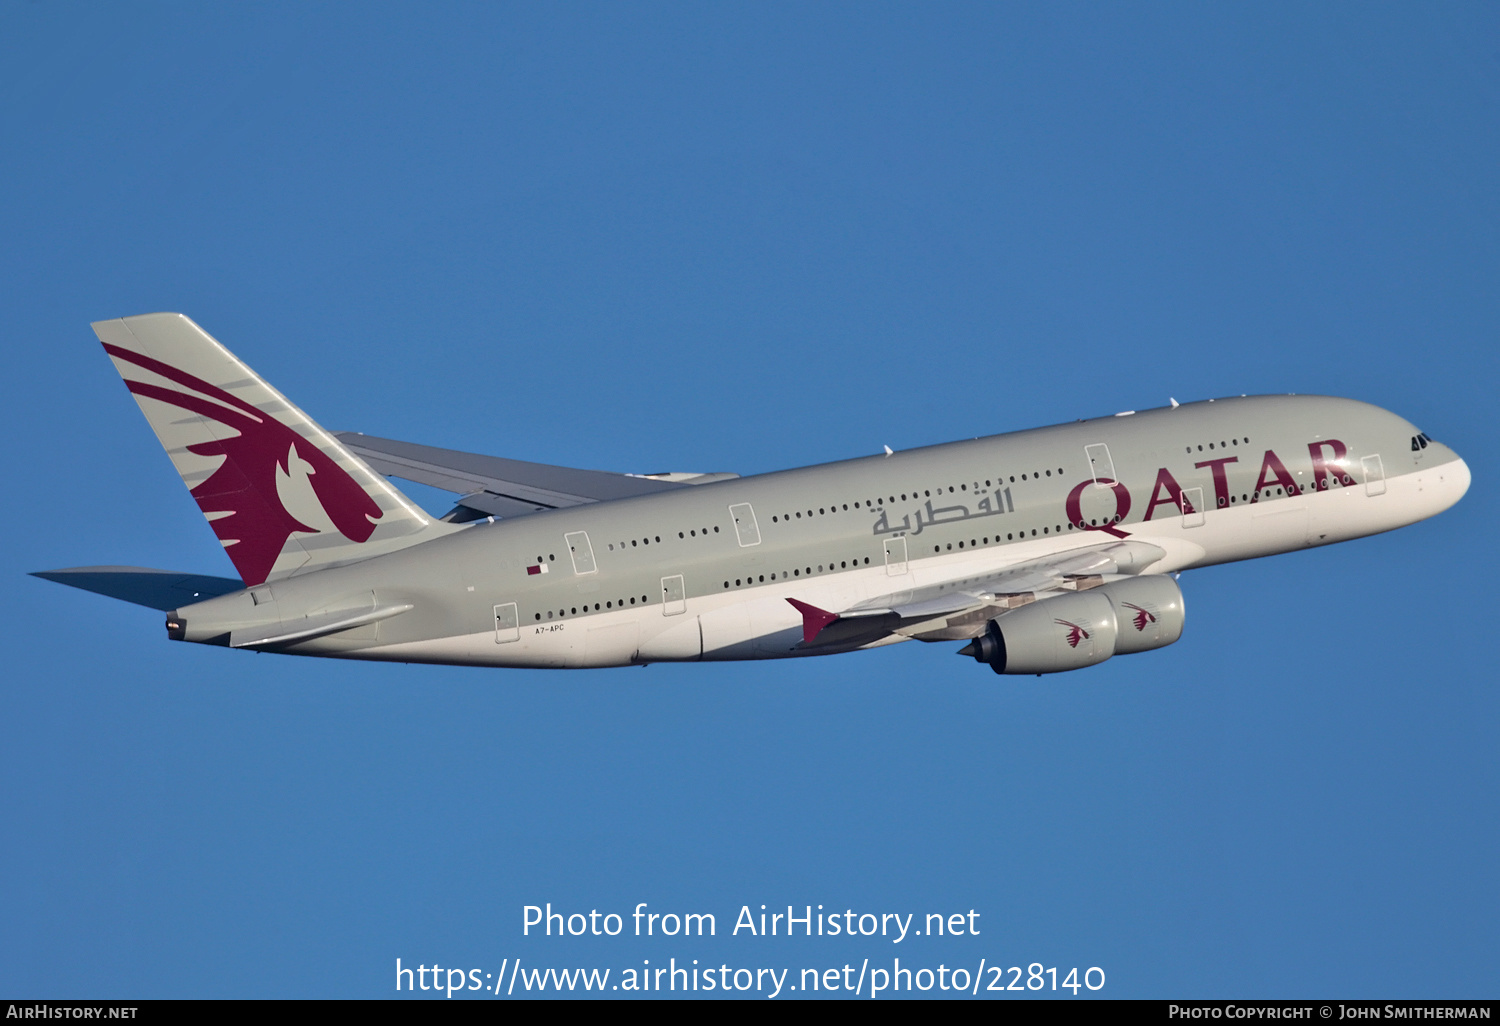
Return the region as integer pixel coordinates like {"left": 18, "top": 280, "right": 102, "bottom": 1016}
{"left": 173, "top": 396, "right": 1469, "bottom": 668}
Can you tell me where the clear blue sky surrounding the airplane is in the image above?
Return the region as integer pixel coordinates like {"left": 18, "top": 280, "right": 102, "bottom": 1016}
{"left": 0, "top": 3, "right": 1500, "bottom": 998}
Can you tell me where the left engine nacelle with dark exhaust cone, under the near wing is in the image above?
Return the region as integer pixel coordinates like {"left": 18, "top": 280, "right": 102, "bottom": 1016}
{"left": 965, "top": 590, "right": 1119, "bottom": 674}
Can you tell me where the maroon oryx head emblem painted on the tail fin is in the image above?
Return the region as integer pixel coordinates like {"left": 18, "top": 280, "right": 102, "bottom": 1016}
{"left": 104, "top": 342, "right": 383, "bottom": 585}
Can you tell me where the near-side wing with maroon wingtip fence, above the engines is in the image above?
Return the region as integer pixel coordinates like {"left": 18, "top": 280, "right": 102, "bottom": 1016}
{"left": 788, "top": 540, "right": 1167, "bottom": 648}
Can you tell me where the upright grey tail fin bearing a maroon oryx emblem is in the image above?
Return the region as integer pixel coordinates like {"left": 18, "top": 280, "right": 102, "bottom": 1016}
{"left": 93, "top": 314, "right": 461, "bottom": 587}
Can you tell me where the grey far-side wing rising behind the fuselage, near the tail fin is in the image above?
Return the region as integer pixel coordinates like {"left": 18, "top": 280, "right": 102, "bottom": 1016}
{"left": 335, "top": 431, "right": 738, "bottom": 524}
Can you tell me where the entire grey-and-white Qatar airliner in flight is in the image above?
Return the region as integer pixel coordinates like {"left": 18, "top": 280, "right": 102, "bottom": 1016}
{"left": 36, "top": 314, "right": 1470, "bottom": 675}
